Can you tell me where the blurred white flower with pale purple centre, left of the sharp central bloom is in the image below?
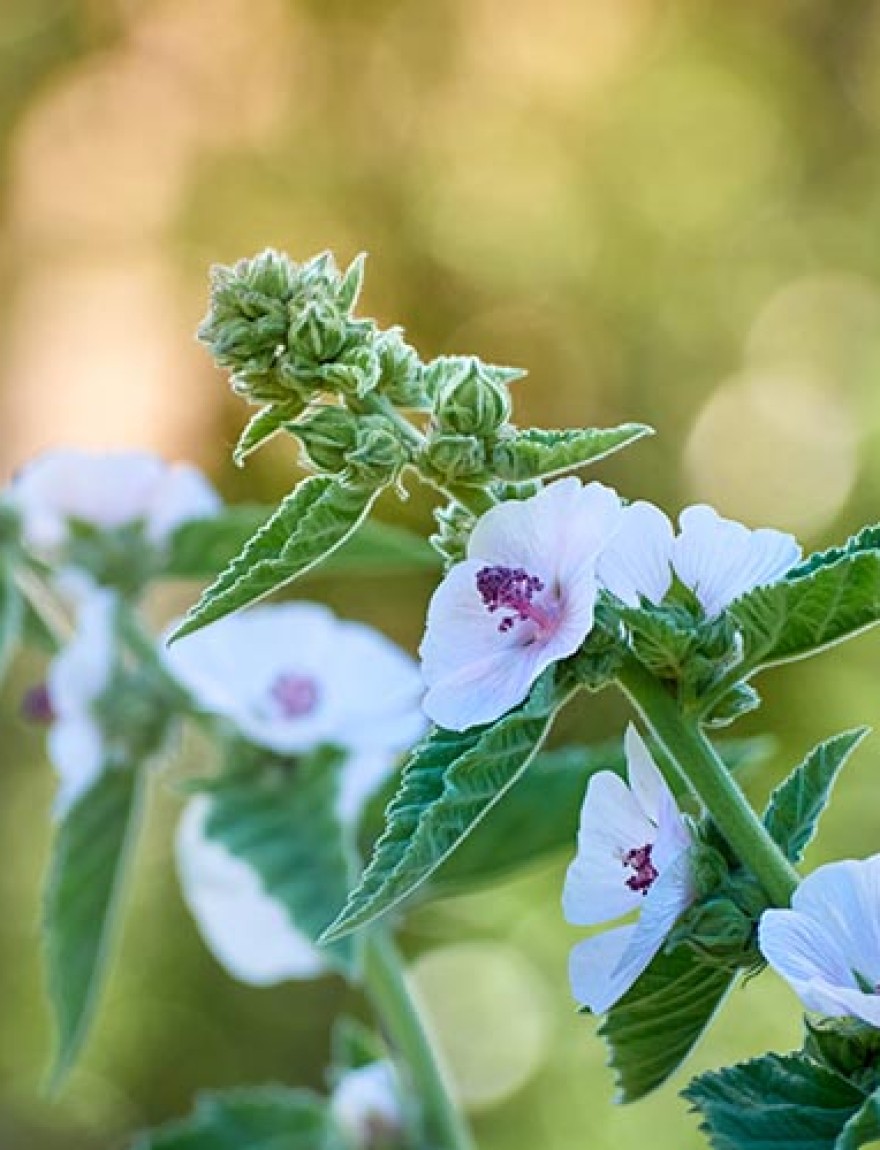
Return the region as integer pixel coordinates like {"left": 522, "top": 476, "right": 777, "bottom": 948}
{"left": 164, "top": 603, "right": 426, "bottom": 819}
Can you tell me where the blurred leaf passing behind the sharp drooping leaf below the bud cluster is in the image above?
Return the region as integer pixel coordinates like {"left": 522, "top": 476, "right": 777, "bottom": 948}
{"left": 164, "top": 504, "right": 439, "bottom": 580}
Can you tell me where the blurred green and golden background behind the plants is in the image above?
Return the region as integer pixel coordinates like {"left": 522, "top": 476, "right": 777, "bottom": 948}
{"left": 0, "top": 0, "right": 880, "bottom": 1150}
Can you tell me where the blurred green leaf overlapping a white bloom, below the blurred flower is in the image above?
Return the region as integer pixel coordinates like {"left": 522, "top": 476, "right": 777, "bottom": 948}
{"left": 205, "top": 754, "right": 358, "bottom": 975}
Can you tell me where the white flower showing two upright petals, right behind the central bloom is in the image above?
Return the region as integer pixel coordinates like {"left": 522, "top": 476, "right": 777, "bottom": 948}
{"left": 597, "top": 501, "right": 801, "bottom": 619}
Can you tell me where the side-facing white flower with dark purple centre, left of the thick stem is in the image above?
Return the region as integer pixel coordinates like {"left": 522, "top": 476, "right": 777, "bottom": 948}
{"left": 563, "top": 726, "right": 695, "bottom": 1014}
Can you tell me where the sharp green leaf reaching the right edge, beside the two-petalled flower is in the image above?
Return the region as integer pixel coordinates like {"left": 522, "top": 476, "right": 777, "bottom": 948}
{"left": 729, "top": 531, "right": 880, "bottom": 679}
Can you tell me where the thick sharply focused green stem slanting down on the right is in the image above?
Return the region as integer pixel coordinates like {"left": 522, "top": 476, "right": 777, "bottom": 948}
{"left": 618, "top": 656, "right": 799, "bottom": 906}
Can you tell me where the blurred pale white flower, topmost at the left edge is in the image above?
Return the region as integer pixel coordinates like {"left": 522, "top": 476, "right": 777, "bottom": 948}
{"left": 7, "top": 450, "right": 220, "bottom": 559}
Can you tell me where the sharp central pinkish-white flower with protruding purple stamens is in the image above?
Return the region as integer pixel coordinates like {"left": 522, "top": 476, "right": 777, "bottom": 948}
{"left": 420, "top": 478, "right": 620, "bottom": 730}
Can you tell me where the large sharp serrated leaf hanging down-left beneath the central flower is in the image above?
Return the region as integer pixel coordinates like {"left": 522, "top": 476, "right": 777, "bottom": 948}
{"left": 324, "top": 668, "right": 571, "bottom": 940}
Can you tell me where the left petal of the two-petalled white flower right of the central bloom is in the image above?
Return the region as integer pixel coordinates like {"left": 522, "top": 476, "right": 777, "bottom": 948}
{"left": 596, "top": 500, "right": 673, "bottom": 607}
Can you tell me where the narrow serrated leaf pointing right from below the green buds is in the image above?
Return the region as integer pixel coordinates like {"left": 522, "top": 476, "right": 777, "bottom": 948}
{"left": 491, "top": 423, "right": 653, "bottom": 483}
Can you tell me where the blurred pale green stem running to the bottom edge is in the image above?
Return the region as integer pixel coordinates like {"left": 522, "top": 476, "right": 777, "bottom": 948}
{"left": 364, "top": 930, "right": 475, "bottom": 1150}
